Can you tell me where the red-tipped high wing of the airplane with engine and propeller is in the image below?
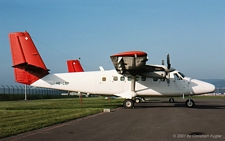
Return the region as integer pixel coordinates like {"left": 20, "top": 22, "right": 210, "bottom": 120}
{"left": 110, "top": 51, "right": 175, "bottom": 78}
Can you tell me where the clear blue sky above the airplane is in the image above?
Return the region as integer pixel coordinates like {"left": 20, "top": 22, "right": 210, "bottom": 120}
{"left": 0, "top": 0, "right": 225, "bottom": 85}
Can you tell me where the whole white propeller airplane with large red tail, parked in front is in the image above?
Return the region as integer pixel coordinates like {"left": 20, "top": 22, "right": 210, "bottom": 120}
{"left": 9, "top": 31, "right": 215, "bottom": 109}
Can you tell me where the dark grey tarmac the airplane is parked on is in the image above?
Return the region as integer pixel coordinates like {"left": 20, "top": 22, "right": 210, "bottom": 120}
{"left": 1, "top": 98, "right": 225, "bottom": 141}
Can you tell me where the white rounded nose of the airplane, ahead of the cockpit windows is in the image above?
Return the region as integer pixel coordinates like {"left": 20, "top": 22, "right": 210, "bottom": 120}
{"left": 191, "top": 79, "right": 216, "bottom": 94}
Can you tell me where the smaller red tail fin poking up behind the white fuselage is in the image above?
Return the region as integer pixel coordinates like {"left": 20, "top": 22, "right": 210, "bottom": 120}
{"left": 67, "top": 60, "right": 84, "bottom": 72}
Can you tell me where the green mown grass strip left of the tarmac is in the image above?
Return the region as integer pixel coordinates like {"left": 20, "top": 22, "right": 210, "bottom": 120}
{"left": 0, "top": 98, "right": 122, "bottom": 138}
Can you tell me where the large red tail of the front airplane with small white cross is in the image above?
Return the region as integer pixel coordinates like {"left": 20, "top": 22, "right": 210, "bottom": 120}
{"left": 9, "top": 32, "right": 49, "bottom": 85}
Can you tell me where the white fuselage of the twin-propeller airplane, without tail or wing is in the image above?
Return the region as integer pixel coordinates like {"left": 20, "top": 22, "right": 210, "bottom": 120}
{"left": 31, "top": 70, "right": 215, "bottom": 98}
